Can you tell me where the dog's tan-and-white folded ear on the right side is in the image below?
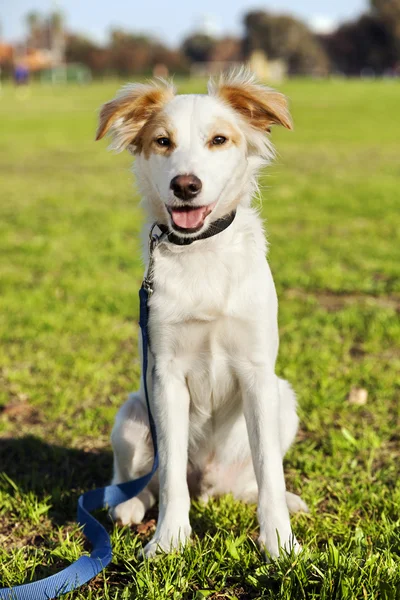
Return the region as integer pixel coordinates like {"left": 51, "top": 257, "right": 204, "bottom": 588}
{"left": 209, "top": 69, "right": 293, "bottom": 132}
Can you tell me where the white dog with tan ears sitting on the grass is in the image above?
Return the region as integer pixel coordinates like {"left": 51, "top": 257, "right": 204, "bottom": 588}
{"left": 97, "top": 71, "right": 307, "bottom": 557}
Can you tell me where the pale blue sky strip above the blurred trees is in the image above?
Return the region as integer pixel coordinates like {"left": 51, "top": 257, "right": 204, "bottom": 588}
{"left": 0, "top": 0, "right": 368, "bottom": 46}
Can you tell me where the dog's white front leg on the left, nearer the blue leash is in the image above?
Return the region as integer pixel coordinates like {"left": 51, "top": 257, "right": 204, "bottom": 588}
{"left": 144, "top": 365, "right": 191, "bottom": 556}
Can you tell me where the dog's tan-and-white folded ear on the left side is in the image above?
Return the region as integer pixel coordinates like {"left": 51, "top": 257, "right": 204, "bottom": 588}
{"left": 96, "top": 80, "right": 174, "bottom": 151}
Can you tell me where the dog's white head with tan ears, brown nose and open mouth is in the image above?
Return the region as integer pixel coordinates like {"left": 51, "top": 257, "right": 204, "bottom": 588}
{"left": 96, "top": 71, "right": 292, "bottom": 237}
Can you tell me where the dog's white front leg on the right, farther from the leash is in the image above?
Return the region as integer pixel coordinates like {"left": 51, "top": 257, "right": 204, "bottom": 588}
{"left": 243, "top": 365, "right": 300, "bottom": 557}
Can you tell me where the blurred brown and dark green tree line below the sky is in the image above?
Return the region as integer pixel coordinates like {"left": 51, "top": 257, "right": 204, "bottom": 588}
{"left": 3, "top": 0, "right": 400, "bottom": 77}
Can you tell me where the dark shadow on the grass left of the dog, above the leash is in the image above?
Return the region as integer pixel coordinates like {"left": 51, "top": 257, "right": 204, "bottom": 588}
{"left": 0, "top": 436, "right": 112, "bottom": 525}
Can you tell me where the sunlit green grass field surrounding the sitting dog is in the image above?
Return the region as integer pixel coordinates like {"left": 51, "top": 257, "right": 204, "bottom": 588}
{"left": 0, "top": 81, "right": 400, "bottom": 600}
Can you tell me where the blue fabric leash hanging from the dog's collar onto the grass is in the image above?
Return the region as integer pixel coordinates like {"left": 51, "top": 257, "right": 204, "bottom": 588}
{"left": 0, "top": 282, "right": 158, "bottom": 600}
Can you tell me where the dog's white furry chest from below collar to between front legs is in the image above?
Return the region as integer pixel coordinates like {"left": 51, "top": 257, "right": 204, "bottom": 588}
{"left": 144, "top": 218, "right": 276, "bottom": 439}
